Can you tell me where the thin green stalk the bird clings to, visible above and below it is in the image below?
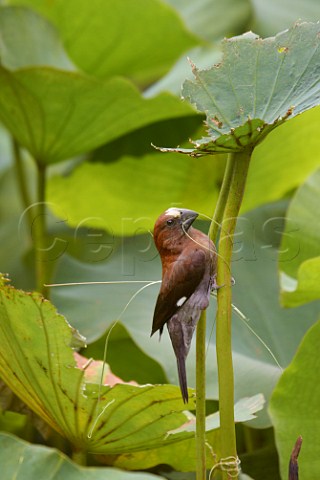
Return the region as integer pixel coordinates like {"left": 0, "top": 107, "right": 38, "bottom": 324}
{"left": 196, "top": 155, "right": 235, "bottom": 480}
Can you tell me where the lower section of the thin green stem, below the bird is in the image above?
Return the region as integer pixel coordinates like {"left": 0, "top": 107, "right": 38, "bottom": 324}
{"left": 196, "top": 310, "right": 206, "bottom": 480}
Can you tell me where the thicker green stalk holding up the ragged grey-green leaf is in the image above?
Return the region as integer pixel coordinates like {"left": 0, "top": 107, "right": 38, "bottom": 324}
{"left": 216, "top": 150, "right": 251, "bottom": 480}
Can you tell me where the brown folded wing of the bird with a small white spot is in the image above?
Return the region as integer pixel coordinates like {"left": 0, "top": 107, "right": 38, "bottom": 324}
{"left": 151, "top": 249, "right": 207, "bottom": 335}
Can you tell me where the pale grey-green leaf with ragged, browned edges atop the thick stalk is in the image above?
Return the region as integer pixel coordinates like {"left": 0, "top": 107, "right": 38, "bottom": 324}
{"left": 157, "top": 23, "right": 320, "bottom": 155}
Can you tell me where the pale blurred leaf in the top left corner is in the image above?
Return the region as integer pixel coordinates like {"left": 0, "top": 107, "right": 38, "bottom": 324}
{"left": 0, "top": 7, "right": 75, "bottom": 70}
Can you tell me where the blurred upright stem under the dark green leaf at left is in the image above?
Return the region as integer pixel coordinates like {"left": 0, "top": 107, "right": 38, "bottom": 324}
{"left": 33, "top": 163, "right": 48, "bottom": 297}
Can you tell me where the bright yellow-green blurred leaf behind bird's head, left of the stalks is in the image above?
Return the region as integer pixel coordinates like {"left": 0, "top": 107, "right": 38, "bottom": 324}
{"left": 48, "top": 154, "right": 220, "bottom": 235}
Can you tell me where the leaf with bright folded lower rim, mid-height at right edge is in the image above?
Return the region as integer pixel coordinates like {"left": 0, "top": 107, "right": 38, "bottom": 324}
{"left": 280, "top": 170, "right": 320, "bottom": 307}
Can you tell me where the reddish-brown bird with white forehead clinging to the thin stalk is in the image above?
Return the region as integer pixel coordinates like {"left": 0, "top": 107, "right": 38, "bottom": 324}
{"left": 151, "top": 208, "right": 217, "bottom": 403}
